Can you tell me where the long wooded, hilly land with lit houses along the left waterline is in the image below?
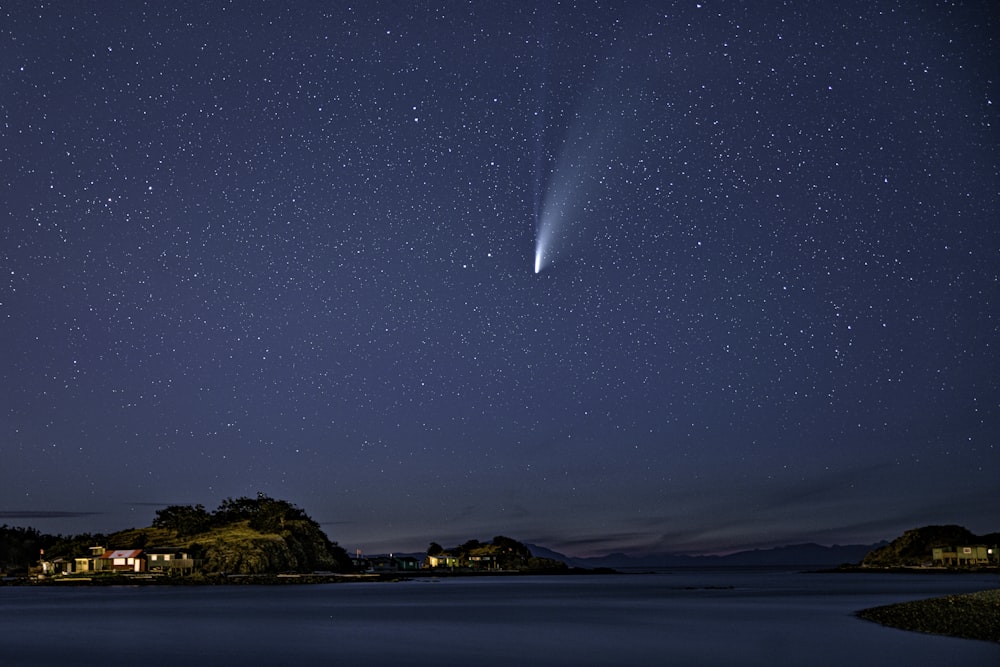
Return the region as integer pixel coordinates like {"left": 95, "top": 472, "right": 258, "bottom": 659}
{"left": 0, "top": 494, "right": 584, "bottom": 585}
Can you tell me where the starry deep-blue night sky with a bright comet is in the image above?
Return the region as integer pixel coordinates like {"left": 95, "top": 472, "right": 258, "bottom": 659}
{"left": 0, "top": 0, "right": 1000, "bottom": 556}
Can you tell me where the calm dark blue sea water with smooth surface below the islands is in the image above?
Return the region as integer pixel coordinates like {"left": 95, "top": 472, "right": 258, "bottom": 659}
{"left": 0, "top": 570, "right": 1000, "bottom": 667}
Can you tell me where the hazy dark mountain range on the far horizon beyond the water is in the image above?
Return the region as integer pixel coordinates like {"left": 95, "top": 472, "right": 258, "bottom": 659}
{"left": 527, "top": 542, "right": 887, "bottom": 569}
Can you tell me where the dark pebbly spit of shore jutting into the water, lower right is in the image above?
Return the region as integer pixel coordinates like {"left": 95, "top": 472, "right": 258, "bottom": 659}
{"left": 858, "top": 589, "right": 1000, "bottom": 642}
